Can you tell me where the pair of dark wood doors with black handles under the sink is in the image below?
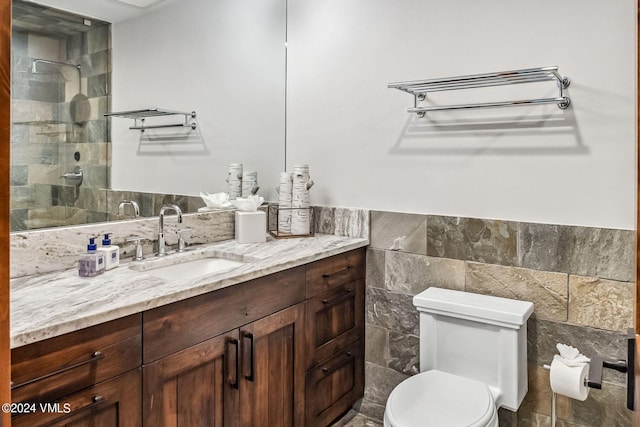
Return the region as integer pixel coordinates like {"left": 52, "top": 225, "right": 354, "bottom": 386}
{"left": 143, "top": 303, "right": 305, "bottom": 427}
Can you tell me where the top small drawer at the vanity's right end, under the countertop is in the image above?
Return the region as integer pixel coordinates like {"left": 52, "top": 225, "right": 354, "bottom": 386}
{"left": 307, "top": 248, "right": 365, "bottom": 298}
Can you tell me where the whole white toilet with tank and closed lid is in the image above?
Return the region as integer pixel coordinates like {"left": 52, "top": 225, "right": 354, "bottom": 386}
{"left": 384, "top": 287, "right": 533, "bottom": 427}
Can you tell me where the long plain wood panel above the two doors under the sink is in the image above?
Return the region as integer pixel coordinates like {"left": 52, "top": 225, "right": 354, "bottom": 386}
{"left": 142, "top": 266, "right": 305, "bottom": 364}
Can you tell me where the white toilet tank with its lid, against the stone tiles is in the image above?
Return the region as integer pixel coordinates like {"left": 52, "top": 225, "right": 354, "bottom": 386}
{"left": 413, "top": 287, "right": 533, "bottom": 411}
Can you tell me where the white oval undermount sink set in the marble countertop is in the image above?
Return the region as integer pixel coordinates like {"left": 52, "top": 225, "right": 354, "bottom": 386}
{"left": 129, "top": 251, "right": 245, "bottom": 280}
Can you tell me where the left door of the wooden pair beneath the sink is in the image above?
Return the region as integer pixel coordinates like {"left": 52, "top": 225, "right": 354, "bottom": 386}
{"left": 143, "top": 330, "right": 240, "bottom": 427}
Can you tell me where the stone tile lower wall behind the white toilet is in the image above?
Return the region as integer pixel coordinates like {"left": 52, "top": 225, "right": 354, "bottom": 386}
{"left": 361, "top": 211, "right": 635, "bottom": 427}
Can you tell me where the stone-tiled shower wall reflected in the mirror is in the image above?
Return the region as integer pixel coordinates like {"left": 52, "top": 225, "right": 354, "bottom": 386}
{"left": 11, "top": 0, "right": 111, "bottom": 230}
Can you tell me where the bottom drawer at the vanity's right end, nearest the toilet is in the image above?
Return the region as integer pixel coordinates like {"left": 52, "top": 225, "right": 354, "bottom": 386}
{"left": 305, "top": 340, "right": 364, "bottom": 427}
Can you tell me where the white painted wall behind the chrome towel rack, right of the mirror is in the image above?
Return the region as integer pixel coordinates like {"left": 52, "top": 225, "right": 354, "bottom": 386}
{"left": 287, "top": 0, "right": 636, "bottom": 229}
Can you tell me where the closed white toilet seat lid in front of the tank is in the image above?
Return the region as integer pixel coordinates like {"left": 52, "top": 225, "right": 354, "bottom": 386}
{"left": 384, "top": 369, "right": 498, "bottom": 427}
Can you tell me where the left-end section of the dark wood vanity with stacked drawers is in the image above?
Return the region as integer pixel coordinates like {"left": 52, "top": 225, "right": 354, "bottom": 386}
{"left": 11, "top": 314, "right": 142, "bottom": 427}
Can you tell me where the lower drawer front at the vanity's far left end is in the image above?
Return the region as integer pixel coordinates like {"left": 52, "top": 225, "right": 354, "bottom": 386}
{"left": 11, "top": 368, "right": 141, "bottom": 427}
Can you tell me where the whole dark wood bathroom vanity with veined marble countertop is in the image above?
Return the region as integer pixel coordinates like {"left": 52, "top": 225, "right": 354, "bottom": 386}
{"left": 12, "top": 235, "right": 368, "bottom": 426}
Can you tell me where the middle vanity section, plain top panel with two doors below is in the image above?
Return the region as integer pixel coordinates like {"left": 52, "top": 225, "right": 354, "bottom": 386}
{"left": 143, "top": 267, "right": 306, "bottom": 427}
